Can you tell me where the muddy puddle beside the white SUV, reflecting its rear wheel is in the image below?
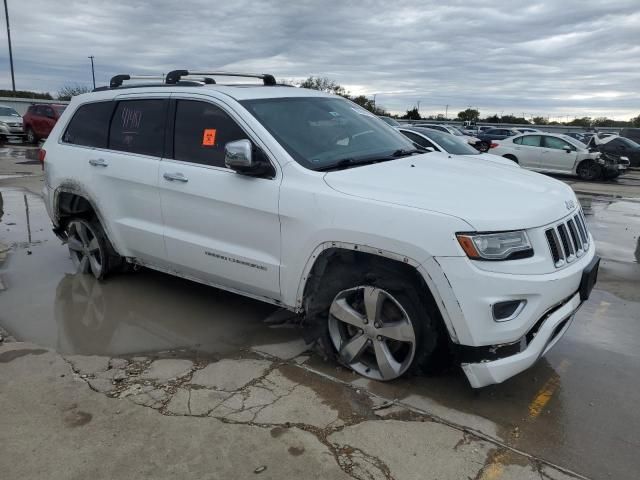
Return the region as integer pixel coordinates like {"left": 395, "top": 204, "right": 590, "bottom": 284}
{"left": 0, "top": 189, "right": 300, "bottom": 355}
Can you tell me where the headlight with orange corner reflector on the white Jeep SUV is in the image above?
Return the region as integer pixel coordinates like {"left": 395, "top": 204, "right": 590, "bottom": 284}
{"left": 456, "top": 230, "right": 533, "bottom": 260}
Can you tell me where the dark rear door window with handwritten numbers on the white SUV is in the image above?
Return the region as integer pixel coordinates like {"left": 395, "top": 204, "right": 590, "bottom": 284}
{"left": 109, "top": 99, "right": 167, "bottom": 157}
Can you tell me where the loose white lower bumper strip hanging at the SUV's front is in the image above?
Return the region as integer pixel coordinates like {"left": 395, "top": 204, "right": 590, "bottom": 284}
{"left": 462, "top": 293, "right": 582, "bottom": 388}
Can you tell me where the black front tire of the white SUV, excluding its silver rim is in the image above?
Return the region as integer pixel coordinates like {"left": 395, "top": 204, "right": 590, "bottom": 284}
{"left": 305, "top": 263, "right": 444, "bottom": 378}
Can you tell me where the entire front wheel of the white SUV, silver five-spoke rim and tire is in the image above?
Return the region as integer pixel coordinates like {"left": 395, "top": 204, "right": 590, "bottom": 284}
{"left": 312, "top": 266, "right": 440, "bottom": 381}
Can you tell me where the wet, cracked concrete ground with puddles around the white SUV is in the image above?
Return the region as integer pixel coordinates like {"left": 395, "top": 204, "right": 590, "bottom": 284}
{"left": 0, "top": 147, "right": 640, "bottom": 479}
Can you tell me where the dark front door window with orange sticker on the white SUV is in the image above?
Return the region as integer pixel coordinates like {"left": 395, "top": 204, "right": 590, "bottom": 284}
{"left": 173, "top": 100, "right": 247, "bottom": 167}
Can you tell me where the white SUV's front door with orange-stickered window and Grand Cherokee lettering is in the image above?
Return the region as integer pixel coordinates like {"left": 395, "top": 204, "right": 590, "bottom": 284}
{"left": 159, "top": 95, "right": 281, "bottom": 299}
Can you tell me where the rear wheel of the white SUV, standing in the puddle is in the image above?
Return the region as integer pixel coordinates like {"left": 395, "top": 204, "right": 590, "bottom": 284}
{"left": 66, "top": 217, "right": 124, "bottom": 280}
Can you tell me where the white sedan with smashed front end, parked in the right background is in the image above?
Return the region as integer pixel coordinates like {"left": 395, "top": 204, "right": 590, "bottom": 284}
{"left": 491, "top": 132, "right": 626, "bottom": 180}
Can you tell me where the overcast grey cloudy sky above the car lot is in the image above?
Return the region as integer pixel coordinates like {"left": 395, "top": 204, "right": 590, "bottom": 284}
{"left": 0, "top": 0, "right": 640, "bottom": 120}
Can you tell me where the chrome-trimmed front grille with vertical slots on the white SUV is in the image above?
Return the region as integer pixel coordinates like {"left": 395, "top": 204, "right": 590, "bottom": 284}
{"left": 544, "top": 210, "right": 589, "bottom": 268}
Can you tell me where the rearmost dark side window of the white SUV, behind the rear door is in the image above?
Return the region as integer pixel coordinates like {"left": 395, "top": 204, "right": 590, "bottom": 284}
{"left": 62, "top": 102, "right": 113, "bottom": 148}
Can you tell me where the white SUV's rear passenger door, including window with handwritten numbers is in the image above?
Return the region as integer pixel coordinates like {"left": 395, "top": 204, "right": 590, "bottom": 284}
{"left": 81, "top": 95, "right": 169, "bottom": 265}
